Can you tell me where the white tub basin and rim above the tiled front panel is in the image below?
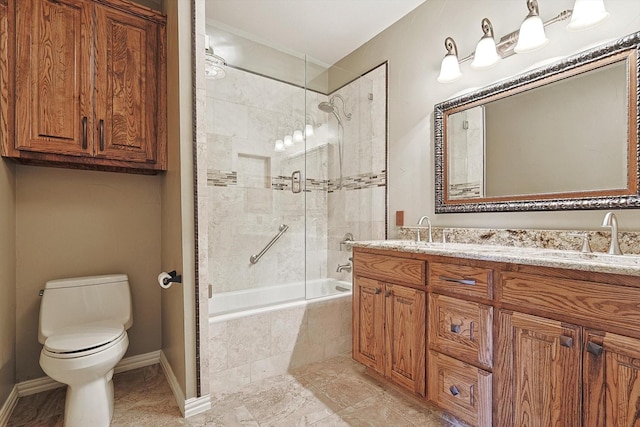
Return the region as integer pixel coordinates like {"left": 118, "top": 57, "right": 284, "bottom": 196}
{"left": 209, "top": 279, "right": 351, "bottom": 318}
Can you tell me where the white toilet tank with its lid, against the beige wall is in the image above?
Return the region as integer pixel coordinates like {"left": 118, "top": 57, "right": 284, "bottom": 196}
{"left": 38, "top": 274, "right": 133, "bottom": 344}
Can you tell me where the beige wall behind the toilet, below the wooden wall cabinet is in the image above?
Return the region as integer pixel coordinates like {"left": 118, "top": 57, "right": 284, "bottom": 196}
{"left": 16, "top": 166, "right": 161, "bottom": 382}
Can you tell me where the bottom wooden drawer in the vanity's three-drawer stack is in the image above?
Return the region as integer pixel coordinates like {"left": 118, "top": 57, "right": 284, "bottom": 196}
{"left": 428, "top": 351, "right": 492, "bottom": 426}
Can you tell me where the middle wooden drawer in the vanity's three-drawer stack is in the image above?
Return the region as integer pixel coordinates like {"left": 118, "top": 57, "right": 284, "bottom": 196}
{"left": 428, "top": 294, "right": 493, "bottom": 369}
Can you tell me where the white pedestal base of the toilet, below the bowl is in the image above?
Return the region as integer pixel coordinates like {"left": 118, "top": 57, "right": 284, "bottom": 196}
{"left": 64, "top": 370, "right": 113, "bottom": 427}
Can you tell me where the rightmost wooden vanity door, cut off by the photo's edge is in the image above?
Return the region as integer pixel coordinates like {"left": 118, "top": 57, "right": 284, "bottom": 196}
{"left": 584, "top": 331, "right": 640, "bottom": 427}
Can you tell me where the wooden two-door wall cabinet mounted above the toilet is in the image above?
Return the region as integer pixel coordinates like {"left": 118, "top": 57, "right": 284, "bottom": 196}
{"left": 0, "top": 0, "right": 167, "bottom": 173}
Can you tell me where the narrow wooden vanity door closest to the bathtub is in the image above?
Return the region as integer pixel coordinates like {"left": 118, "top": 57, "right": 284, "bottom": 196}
{"left": 352, "top": 276, "right": 384, "bottom": 374}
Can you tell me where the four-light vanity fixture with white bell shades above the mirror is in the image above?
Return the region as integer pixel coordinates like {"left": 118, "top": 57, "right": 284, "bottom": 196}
{"left": 437, "top": 0, "right": 609, "bottom": 83}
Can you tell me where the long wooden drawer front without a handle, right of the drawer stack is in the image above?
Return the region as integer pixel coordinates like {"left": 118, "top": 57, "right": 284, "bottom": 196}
{"left": 501, "top": 272, "right": 640, "bottom": 337}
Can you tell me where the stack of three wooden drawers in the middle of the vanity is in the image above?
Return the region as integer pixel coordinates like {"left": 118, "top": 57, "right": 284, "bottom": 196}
{"left": 427, "top": 261, "right": 493, "bottom": 426}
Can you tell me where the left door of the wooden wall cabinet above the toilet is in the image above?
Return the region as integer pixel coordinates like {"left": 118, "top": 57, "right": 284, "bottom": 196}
{"left": 14, "top": 0, "right": 93, "bottom": 155}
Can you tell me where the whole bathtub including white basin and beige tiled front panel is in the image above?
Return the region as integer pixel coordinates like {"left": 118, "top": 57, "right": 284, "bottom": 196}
{"left": 208, "top": 279, "right": 352, "bottom": 394}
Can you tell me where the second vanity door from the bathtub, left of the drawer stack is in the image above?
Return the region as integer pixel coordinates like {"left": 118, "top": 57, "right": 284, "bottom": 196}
{"left": 385, "top": 283, "right": 426, "bottom": 396}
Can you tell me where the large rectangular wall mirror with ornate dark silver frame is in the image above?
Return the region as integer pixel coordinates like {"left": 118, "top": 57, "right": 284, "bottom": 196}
{"left": 434, "top": 32, "right": 640, "bottom": 213}
